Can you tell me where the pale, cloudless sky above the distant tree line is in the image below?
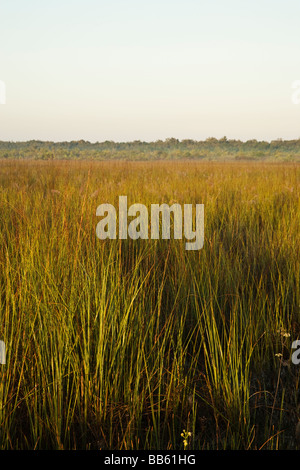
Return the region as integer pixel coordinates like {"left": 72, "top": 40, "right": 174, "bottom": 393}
{"left": 0, "top": 0, "right": 300, "bottom": 142}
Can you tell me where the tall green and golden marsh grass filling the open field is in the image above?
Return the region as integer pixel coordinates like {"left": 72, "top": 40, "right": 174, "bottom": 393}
{"left": 0, "top": 160, "right": 300, "bottom": 450}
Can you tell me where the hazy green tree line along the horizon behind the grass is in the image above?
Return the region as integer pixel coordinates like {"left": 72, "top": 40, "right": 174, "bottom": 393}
{"left": 0, "top": 137, "right": 300, "bottom": 161}
